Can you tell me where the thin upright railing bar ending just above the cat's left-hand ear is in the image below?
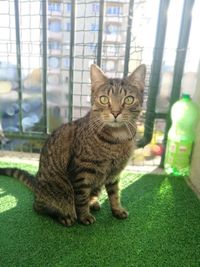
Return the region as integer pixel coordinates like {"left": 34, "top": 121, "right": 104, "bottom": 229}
{"left": 97, "top": 0, "right": 105, "bottom": 67}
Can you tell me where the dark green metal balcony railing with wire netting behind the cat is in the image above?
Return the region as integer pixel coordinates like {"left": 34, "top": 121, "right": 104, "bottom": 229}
{"left": 0, "top": 0, "right": 200, "bottom": 166}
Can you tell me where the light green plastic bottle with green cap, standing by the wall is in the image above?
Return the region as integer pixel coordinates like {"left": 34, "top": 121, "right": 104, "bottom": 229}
{"left": 164, "top": 94, "right": 199, "bottom": 176}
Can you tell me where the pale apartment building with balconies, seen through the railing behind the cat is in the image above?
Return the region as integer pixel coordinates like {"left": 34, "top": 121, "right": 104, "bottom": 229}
{"left": 48, "top": 0, "right": 131, "bottom": 122}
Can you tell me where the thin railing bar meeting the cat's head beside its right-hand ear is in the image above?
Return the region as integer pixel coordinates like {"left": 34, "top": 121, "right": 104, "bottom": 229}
{"left": 124, "top": 0, "right": 134, "bottom": 77}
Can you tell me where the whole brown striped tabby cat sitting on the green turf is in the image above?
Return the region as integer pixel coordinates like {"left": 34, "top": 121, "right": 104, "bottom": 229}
{"left": 0, "top": 64, "right": 146, "bottom": 226}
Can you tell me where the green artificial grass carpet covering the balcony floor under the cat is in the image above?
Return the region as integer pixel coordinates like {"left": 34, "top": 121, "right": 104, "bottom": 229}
{"left": 0, "top": 164, "right": 200, "bottom": 267}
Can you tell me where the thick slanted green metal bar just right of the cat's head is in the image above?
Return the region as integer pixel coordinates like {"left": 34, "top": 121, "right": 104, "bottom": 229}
{"left": 137, "top": 0, "right": 170, "bottom": 147}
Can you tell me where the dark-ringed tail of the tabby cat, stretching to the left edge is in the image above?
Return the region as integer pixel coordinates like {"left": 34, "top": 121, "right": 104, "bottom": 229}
{"left": 0, "top": 168, "right": 36, "bottom": 191}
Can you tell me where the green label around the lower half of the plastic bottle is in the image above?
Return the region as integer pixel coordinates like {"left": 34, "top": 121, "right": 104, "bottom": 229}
{"left": 165, "top": 139, "right": 192, "bottom": 170}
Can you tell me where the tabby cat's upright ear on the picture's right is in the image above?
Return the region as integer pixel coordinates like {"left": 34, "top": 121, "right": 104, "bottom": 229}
{"left": 126, "top": 64, "right": 146, "bottom": 90}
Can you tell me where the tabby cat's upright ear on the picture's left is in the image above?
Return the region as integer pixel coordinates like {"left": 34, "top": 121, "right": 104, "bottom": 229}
{"left": 90, "top": 64, "right": 108, "bottom": 87}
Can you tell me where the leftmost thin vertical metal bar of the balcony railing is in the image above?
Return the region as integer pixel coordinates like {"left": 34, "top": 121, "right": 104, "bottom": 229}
{"left": 14, "top": 0, "right": 23, "bottom": 133}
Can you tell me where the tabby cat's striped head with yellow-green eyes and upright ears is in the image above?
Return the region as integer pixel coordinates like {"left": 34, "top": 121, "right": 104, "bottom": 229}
{"left": 90, "top": 64, "right": 146, "bottom": 127}
